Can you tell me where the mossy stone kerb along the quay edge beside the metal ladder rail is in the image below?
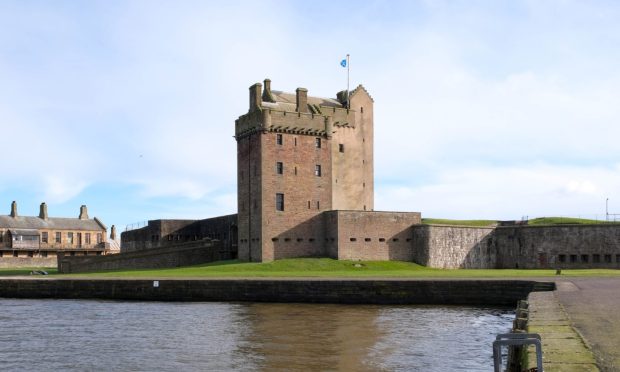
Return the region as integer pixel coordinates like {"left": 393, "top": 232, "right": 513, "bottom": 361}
{"left": 528, "top": 292, "right": 599, "bottom": 372}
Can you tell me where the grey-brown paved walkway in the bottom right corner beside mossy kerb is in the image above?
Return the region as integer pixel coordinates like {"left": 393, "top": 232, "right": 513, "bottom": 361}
{"left": 555, "top": 278, "right": 620, "bottom": 371}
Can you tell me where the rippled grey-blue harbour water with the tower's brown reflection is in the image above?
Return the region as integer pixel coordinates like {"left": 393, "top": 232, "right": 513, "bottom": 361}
{"left": 0, "top": 299, "right": 514, "bottom": 372}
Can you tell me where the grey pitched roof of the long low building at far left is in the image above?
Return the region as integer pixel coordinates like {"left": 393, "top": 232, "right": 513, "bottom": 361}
{"left": 0, "top": 216, "right": 105, "bottom": 231}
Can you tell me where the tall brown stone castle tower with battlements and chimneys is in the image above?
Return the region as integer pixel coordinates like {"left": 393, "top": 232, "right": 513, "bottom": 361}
{"left": 235, "top": 79, "right": 374, "bottom": 261}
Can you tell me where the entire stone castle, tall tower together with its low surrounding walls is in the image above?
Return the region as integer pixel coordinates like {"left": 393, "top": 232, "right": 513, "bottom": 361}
{"left": 117, "top": 79, "right": 620, "bottom": 268}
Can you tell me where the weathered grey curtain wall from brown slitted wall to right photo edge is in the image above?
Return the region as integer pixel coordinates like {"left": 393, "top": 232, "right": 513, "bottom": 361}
{"left": 413, "top": 224, "right": 620, "bottom": 269}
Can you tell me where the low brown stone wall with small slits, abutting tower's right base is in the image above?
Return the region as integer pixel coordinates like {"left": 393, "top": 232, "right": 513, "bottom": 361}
{"left": 323, "top": 211, "right": 420, "bottom": 261}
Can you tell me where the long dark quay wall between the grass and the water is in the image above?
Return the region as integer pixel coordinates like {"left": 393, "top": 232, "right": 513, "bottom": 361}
{"left": 0, "top": 278, "right": 555, "bottom": 306}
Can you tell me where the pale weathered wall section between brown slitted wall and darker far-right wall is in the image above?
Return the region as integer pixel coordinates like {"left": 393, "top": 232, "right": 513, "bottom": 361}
{"left": 413, "top": 225, "right": 497, "bottom": 269}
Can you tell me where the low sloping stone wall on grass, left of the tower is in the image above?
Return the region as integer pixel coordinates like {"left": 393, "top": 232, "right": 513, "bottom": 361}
{"left": 58, "top": 239, "right": 222, "bottom": 274}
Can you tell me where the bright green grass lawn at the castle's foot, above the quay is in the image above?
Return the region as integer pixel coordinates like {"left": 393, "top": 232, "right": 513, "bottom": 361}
{"left": 9, "top": 258, "right": 620, "bottom": 279}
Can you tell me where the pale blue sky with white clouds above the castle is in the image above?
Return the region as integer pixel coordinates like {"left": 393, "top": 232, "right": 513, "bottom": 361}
{"left": 0, "top": 0, "right": 620, "bottom": 230}
